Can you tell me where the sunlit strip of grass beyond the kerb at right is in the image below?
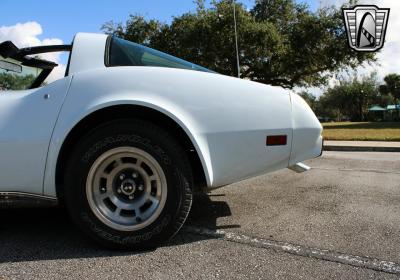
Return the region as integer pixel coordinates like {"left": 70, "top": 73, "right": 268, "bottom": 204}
{"left": 322, "top": 122, "right": 400, "bottom": 141}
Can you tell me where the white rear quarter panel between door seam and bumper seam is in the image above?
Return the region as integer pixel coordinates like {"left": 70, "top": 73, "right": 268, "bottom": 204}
{"left": 44, "top": 67, "right": 292, "bottom": 195}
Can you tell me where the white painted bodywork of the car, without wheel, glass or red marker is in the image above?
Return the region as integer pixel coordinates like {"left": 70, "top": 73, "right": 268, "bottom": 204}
{"left": 0, "top": 33, "right": 322, "bottom": 197}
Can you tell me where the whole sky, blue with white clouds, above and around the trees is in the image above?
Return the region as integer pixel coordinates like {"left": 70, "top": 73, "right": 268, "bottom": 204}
{"left": 0, "top": 0, "right": 400, "bottom": 96}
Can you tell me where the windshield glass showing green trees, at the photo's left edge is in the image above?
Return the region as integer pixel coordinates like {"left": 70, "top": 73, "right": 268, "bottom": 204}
{"left": 0, "top": 55, "right": 42, "bottom": 90}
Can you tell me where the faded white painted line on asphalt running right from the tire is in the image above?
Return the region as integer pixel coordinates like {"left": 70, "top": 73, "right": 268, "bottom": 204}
{"left": 182, "top": 226, "right": 400, "bottom": 274}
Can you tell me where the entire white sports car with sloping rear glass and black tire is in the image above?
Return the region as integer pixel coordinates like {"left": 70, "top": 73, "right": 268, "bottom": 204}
{"left": 0, "top": 33, "right": 322, "bottom": 249}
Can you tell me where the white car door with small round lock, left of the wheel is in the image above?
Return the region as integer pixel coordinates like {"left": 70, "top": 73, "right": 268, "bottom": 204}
{"left": 0, "top": 77, "right": 71, "bottom": 194}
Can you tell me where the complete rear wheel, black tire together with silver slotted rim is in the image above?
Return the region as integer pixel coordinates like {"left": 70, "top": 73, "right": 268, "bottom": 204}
{"left": 65, "top": 120, "right": 192, "bottom": 249}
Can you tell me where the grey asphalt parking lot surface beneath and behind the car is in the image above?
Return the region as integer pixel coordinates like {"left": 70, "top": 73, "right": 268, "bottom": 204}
{"left": 0, "top": 152, "right": 400, "bottom": 279}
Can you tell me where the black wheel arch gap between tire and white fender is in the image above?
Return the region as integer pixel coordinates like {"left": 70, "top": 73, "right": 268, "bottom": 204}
{"left": 55, "top": 104, "right": 208, "bottom": 203}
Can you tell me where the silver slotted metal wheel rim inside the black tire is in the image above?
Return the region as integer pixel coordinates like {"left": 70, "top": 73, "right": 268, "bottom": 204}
{"left": 86, "top": 147, "right": 167, "bottom": 231}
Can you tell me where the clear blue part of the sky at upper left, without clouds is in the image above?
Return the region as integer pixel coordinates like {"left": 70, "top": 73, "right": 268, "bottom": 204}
{"left": 0, "top": 0, "right": 254, "bottom": 42}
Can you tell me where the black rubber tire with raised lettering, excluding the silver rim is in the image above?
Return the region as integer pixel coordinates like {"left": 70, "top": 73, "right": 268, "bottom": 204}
{"left": 64, "top": 120, "right": 193, "bottom": 250}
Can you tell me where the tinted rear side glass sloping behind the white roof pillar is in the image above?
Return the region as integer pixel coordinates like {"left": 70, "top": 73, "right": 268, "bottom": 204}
{"left": 108, "top": 37, "right": 215, "bottom": 73}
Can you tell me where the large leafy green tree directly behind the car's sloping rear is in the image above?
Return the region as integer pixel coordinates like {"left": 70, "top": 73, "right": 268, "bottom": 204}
{"left": 103, "top": 0, "right": 375, "bottom": 88}
